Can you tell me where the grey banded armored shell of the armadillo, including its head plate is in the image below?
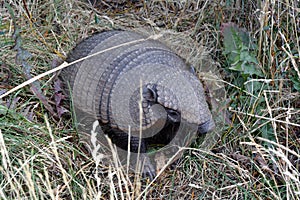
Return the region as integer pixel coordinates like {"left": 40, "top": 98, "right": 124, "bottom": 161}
{"left": 62, "top": 31, "right": 213, "bottom": 136}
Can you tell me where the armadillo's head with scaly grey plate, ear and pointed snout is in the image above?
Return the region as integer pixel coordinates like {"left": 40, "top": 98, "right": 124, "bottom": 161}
{"left": 142, "top": 75, "right": 215, "bottom": 137}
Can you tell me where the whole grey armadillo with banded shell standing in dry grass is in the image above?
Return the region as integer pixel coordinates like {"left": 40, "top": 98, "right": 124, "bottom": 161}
{"left": 61, "top": 30, "right": 214, "bottom": 177}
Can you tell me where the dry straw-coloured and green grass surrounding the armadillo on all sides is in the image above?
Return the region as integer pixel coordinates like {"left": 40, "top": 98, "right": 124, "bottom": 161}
{"left": 0, "top": 0, "right": 300, "bottom": 199}
